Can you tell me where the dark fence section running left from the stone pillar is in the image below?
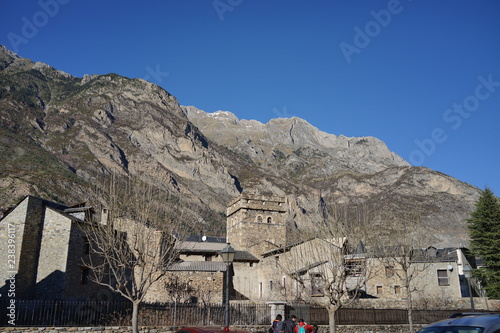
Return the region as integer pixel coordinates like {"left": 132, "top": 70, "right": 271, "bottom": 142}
{"left": 0, "top": 300, "right": 271, "bottom": 327}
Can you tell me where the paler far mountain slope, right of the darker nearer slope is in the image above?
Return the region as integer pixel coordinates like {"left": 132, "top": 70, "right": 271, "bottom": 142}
{"left": 182, "top": 106, "right": 479, "bottom": 246}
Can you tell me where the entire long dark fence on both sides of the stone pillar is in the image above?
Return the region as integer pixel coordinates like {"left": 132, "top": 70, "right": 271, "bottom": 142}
{"left": 0, "top": 300, "right": 474, "bottom": 326}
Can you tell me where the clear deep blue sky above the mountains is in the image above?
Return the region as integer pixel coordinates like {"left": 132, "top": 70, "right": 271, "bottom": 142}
{"left": 0, "top": 0, "right": 500, "bottom": 195}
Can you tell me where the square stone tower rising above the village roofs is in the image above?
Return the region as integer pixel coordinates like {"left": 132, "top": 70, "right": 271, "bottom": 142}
{"left": 227, "top": 194, "right": 287, "bottom": 250}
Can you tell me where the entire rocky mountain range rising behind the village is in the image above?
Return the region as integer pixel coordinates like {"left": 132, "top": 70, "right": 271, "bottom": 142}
{"left": 0, "top": 46, "right": 479, "bottom": 244}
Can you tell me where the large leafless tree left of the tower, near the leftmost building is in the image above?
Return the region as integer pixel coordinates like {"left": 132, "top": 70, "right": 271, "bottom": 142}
{"left": 84, "top": 177, "right": 193, "bottom": 333}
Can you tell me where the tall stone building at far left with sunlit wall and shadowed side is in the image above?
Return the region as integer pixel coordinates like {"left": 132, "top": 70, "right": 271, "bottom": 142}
{"left": 0, "top": 196, "right": 104, "bottom": 299}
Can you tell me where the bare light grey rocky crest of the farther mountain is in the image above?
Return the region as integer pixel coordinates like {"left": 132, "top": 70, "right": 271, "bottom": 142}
{"left": 182, "top": 106, "right": 409, "bottom": 177}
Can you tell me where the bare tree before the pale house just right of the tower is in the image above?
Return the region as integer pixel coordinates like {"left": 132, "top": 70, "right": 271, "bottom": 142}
{"left": 279, "top": 201, "right": 371, "bottom": 333}
